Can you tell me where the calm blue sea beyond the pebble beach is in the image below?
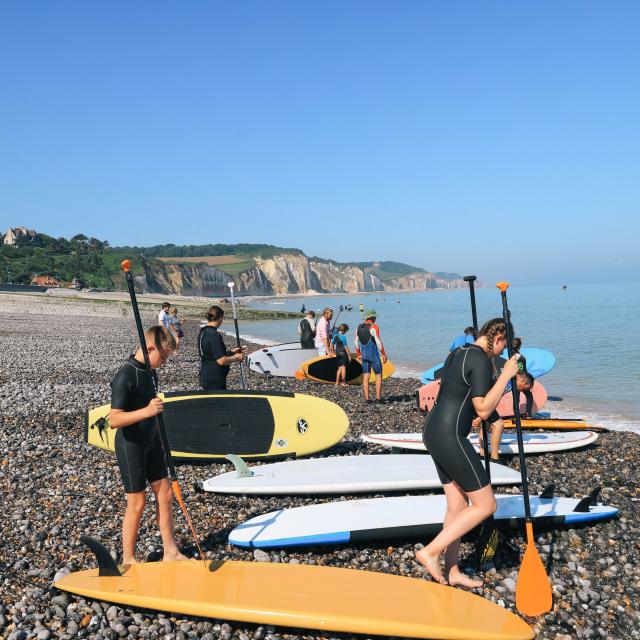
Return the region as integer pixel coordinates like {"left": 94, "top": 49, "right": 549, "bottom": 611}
{"left": 240, "top": 282, "right": 640, "bottom": 433}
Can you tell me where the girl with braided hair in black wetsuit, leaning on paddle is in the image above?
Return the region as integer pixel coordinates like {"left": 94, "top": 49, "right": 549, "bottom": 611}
{"left": 416, "top": 318, "right": 518, "bottom": 588}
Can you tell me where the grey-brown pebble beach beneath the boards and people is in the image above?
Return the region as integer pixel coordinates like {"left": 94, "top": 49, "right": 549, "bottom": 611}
{"left": 0, "top": 294, "right": 640, "bottom": 640}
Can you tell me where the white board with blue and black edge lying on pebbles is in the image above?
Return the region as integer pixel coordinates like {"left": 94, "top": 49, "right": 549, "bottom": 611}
{"left": 229, "top": 494, "right": 618, "bottom": 547}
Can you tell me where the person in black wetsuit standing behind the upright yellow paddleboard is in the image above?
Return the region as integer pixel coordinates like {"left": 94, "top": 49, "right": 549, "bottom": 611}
{"left": 198, "top": 305, "right": 244, "bottom": 391}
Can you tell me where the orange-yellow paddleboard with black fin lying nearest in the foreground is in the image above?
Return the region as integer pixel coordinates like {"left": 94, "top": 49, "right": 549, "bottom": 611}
{"left": 55, "top": 560, "right": 535, "bottom": 640}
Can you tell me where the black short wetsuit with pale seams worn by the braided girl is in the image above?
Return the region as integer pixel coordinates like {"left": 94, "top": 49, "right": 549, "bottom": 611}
{"left": 422, "top": 344, "right": 493, "bottom": 491}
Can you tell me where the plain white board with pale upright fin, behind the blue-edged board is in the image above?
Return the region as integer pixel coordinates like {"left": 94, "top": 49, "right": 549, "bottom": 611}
{"left": 202, "top": 454, "right": 521, "bottom": 495}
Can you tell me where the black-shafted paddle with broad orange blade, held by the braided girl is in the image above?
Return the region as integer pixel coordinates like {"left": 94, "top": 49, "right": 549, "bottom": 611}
{"left": 496, "top": 282, "right": 553, "bottom": 616}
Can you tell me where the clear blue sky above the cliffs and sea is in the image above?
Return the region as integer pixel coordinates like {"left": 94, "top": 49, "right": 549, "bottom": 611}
{"left": 0, "top": 0, "right": 640, "bottom": 284}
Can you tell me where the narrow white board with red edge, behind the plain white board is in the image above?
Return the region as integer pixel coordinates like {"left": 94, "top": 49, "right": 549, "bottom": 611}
{"left": 362, "top": 431, "right": 598, "bottom": 455}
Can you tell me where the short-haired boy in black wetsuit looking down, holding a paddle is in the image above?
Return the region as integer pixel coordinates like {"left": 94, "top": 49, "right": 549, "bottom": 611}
{"left": 109, "top": 326, "right": 186, "bottom": 564}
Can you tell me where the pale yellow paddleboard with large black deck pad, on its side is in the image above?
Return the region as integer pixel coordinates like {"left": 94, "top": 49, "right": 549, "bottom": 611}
{"left": 85, "top": 391, "right": 349, "bottom": 461}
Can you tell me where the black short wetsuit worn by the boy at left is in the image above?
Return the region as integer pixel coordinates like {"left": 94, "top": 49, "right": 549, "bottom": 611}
{"left": 111, "top": 356, "right": 167, "bottom": 493}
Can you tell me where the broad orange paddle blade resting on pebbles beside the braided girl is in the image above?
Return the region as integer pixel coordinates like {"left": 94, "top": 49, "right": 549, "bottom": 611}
{"left": 516, "top": 522, "right": 553, "bottom": 617}
